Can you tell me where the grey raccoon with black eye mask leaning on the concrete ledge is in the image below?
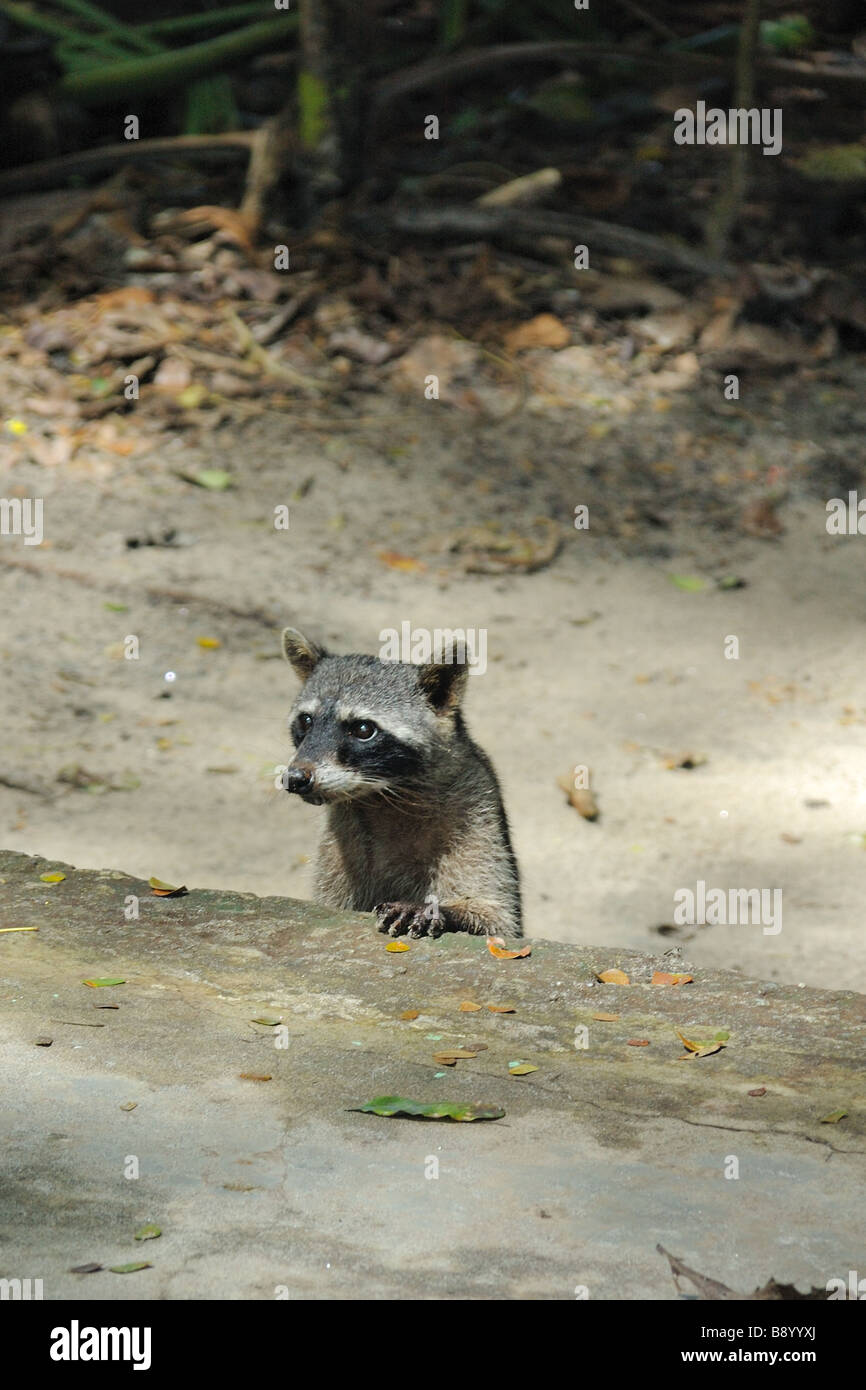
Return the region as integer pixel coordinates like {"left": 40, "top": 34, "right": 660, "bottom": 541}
{"left": 282, "top": 628, "right": 523, "bottom": 937}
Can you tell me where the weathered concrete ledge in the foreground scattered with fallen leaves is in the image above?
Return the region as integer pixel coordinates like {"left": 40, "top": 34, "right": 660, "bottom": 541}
{"left": 0, "top": 853, "right": 866, "bottom": 1300}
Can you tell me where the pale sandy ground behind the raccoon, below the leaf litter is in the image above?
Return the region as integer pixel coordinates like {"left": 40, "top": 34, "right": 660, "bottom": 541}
{"left": 0, "top": 380, "right": 866, "bottom": 990}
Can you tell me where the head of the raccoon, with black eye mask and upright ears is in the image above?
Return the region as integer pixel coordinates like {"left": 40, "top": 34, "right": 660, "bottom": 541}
{"left": 282, "top": 627, "right": 468, "bottom": 805}
